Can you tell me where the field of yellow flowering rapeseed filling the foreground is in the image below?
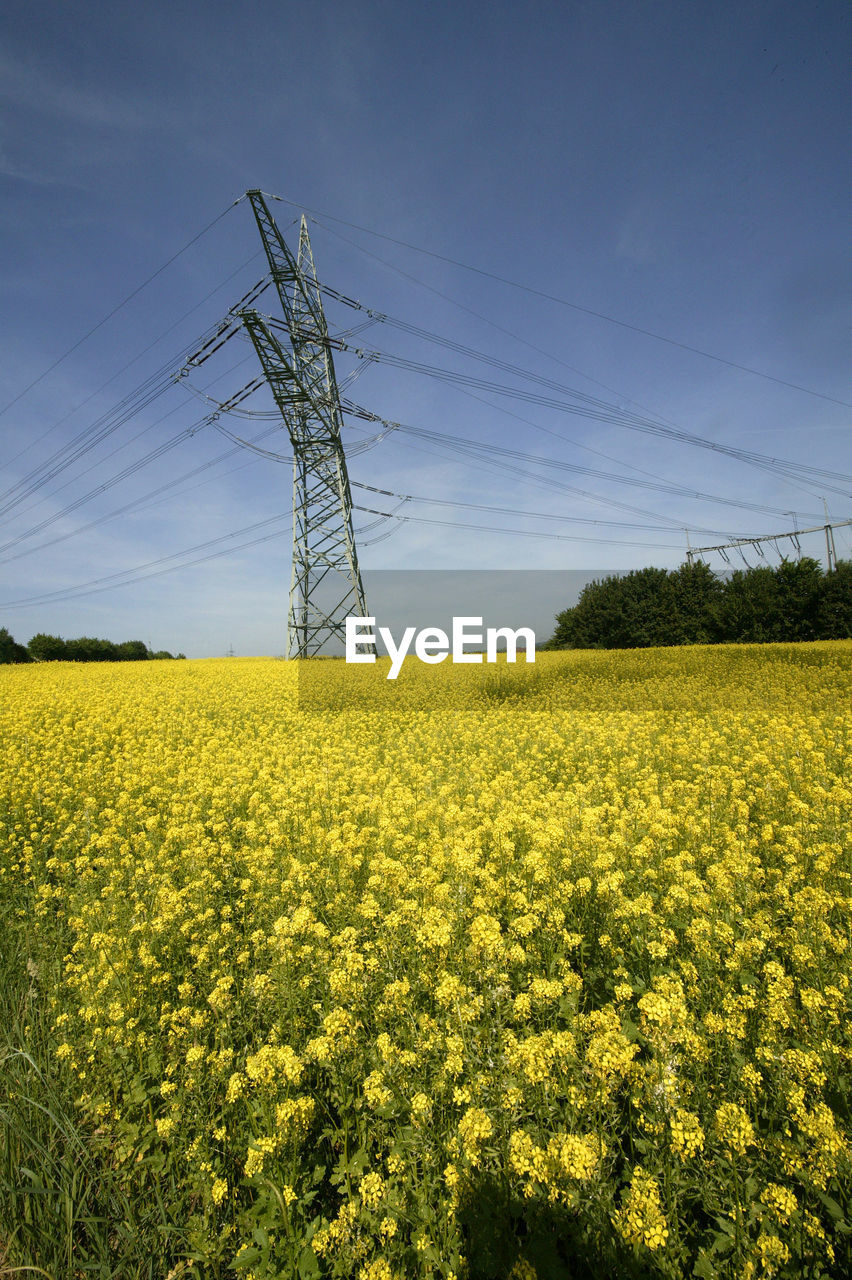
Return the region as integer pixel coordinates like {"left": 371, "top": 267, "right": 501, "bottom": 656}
{"left": 0, "top": 643, "right": 852, "bottom": 1280}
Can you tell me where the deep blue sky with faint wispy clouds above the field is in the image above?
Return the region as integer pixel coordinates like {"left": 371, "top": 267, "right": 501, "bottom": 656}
{"left": 0, "top": 0, "right": 852, "bottom": 655}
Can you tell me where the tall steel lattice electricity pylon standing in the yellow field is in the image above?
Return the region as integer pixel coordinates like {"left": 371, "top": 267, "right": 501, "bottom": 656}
{"left": 241, "top": 191, "right": 367, "bottom": 658}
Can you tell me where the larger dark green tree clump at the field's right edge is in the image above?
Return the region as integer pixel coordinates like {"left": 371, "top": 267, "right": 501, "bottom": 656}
{"left": 548, "top": 557, "right": 852, "bottom": 649}
